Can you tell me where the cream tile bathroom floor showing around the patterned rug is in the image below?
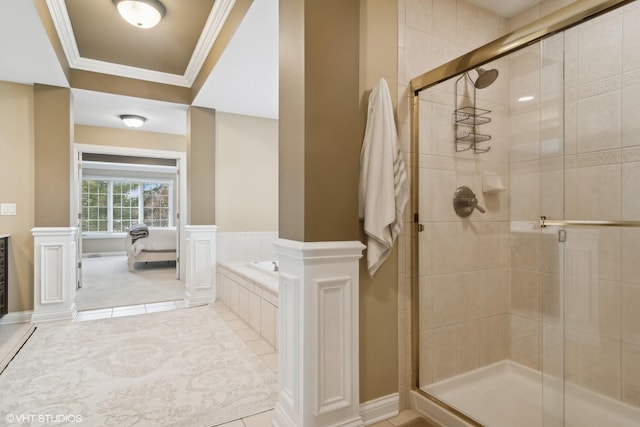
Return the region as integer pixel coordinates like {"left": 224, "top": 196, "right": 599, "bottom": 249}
{"left": 0, "top": 300, "right": 431, "bottom": 427}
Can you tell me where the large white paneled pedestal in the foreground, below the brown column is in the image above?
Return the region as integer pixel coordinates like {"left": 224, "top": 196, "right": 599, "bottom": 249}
{"left": 273, "top": 239, "right": 364, "bottom": 427}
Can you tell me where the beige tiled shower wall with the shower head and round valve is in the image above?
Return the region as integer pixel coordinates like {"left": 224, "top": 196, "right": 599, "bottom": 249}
{"left": 398, "top": 0, "right": 509, "bottom": 398}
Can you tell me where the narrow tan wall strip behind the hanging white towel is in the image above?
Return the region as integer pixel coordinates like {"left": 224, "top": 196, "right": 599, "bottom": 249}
{"left": 356, "top": 0, "right": 400, "bottom": 402}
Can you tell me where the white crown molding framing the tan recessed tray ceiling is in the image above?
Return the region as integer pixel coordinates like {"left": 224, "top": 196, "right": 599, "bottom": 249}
{"left": 46, "top": 0, "right": 236, "bottom": 87}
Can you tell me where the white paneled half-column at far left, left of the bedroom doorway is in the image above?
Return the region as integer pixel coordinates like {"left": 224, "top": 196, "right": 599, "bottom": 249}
{"left": 31, "top": 227, "right": 78, "bottom": 323}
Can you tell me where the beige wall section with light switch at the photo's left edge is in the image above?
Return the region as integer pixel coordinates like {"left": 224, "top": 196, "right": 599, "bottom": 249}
{"left": 0, "top": 82, "right": 35, "bottom": 312}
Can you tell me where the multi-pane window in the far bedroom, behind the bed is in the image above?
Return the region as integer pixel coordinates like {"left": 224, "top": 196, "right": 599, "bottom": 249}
{"left": 82, "top": 179, "right": 173, "bottom": 233}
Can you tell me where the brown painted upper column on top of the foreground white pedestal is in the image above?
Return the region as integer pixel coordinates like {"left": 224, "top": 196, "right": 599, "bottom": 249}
{"left": 279, "top": 0, "right": 362, "bottom": 242}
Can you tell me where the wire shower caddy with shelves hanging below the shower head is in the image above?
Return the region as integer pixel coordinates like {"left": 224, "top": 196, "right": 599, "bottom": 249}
{"left": 453, "top": 73, "right": 491, "bottom": 153}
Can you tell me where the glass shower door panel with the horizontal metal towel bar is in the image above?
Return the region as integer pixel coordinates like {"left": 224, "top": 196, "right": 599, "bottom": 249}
{"left": 540, "top": 2, "right": 640, "bottom": 427}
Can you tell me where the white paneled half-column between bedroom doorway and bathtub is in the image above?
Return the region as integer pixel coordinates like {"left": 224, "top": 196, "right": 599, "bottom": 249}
{"left": 181, "top": 225, "right": 218, "bottom": 306}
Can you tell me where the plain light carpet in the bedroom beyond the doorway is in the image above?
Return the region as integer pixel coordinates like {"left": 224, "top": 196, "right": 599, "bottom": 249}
{"left": 76, "top": 255, "right": 185, "bottom": 311}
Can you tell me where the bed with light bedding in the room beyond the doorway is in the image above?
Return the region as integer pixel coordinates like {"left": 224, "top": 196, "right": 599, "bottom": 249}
{"left": 126, "top": 224, "right": 176, "bottom": 271}
